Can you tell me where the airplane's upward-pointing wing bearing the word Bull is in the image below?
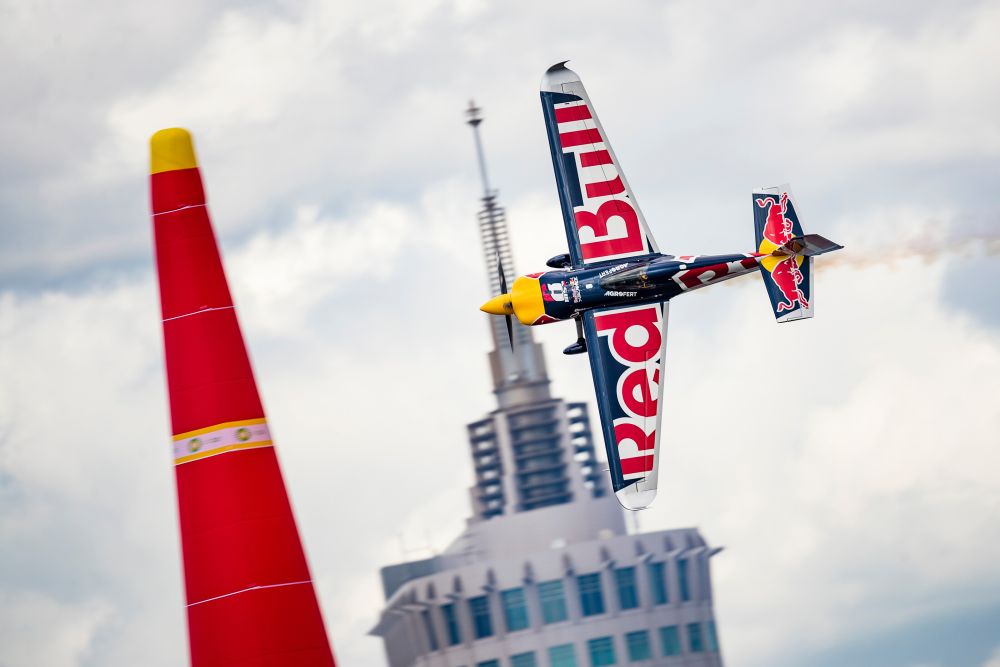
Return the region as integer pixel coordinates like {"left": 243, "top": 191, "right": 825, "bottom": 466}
{"left": 541, "top": 63, "right": 658, "bottom": 267}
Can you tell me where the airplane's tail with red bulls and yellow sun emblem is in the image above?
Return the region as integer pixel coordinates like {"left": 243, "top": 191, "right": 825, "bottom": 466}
{"left": 753, "top": 185, "right": 843, "bottom": 322}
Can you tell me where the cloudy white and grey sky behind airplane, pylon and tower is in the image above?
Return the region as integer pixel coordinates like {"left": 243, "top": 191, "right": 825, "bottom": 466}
{"left": 0, "top": 0, "right": 1000, "bottom": 667}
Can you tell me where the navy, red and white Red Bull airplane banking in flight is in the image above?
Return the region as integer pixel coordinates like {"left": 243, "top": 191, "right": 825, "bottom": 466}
{"left": 481, "top": 61, "right": 843, "bottom": 510}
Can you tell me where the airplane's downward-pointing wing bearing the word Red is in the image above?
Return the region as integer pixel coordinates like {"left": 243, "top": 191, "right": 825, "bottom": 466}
{"left": 583, "top": 303, "right": 669, "bottom": 510}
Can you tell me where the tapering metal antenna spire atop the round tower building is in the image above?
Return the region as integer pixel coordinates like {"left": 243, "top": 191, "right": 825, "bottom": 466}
{"left": 465, "top": 100, "right": 550, "bottom": 408}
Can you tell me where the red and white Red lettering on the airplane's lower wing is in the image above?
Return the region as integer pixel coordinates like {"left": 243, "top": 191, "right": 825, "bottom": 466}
{"left": 594, "top": 305, "right": 663, "bottom": 479}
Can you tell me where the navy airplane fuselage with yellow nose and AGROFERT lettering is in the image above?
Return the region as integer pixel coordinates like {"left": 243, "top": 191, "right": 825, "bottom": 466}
{"left": 497, "top": 253, "right": 760, "bottom": 325}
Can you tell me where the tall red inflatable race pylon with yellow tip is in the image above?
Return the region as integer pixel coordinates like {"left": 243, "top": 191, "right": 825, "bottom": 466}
{"left": 150, "top": 128, "right": 334, "bottom": 667}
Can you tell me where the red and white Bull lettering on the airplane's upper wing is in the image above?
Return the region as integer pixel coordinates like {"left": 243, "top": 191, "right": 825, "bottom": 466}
{"left": 555, "top": 100, "right": 650, "bottom": 262}
